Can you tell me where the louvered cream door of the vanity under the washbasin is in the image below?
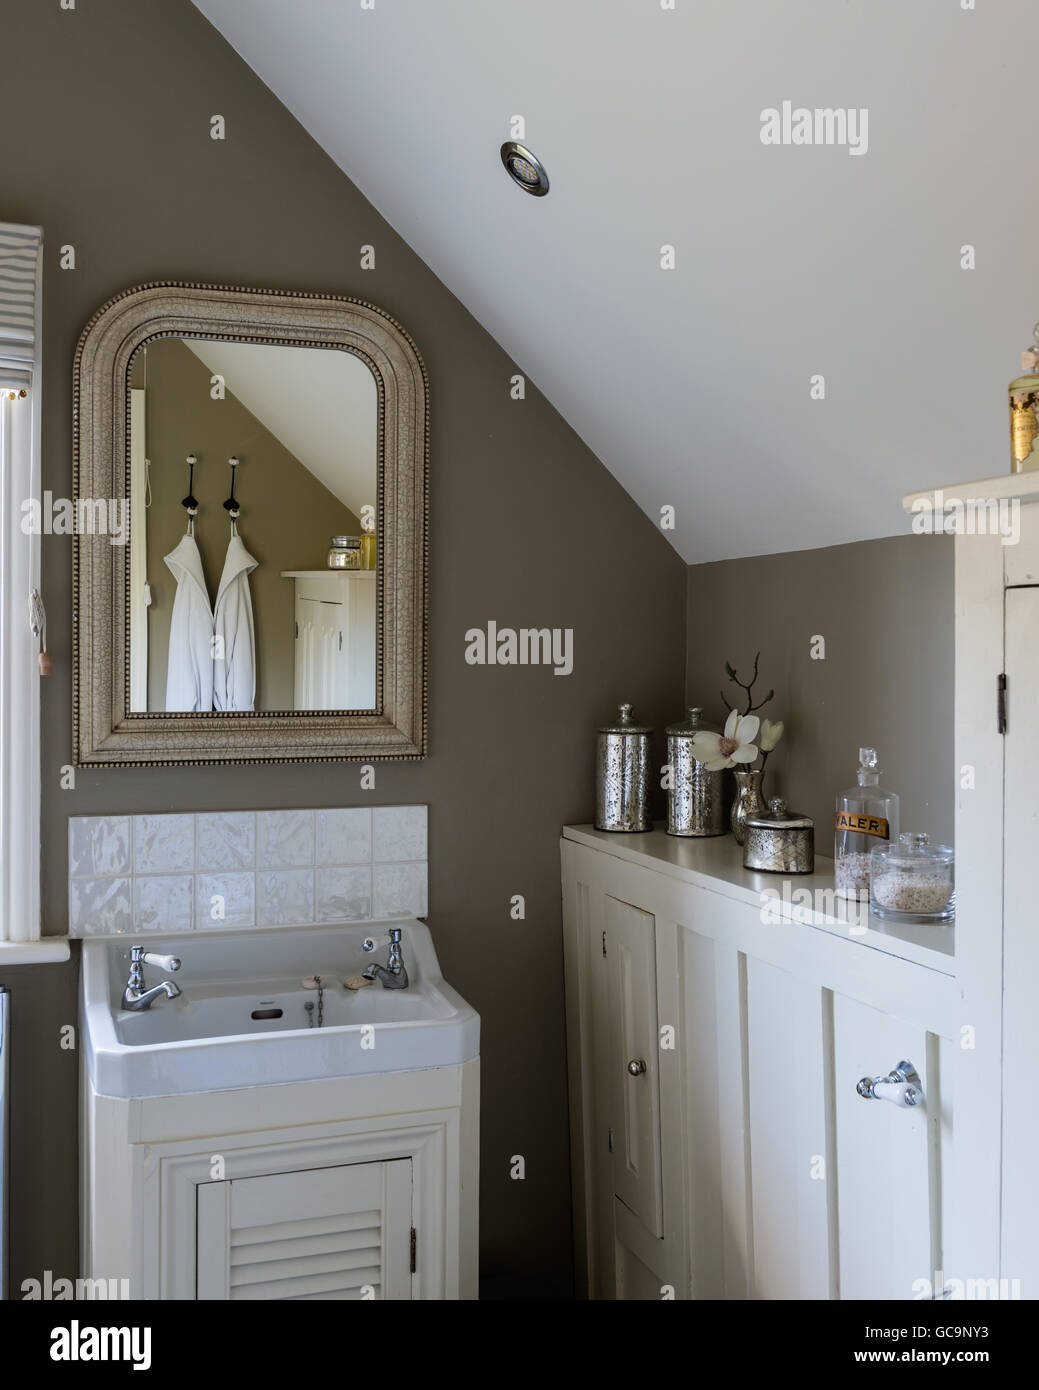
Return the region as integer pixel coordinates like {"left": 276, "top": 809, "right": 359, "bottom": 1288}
{"left": 196, "top": 1158, "right": 412, "bottom": 1300}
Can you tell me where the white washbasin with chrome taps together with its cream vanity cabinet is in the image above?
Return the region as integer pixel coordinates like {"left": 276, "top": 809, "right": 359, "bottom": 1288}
{"left": 79, "top": 919, "right": 480, "bottom": 1301}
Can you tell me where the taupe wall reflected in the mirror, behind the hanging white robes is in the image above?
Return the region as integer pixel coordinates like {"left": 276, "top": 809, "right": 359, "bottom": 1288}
{"left": 145, "top": 338, "right": 361, "bottom": 709}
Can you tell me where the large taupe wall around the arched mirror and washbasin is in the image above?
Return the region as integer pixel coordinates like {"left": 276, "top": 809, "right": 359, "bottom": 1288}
{"left": 0, "top": 0, "right": 686, "bottom": 1291}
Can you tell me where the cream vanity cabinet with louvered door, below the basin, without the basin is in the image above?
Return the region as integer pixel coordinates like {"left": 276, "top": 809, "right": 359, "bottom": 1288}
{"left": 83, "top": 1061, "right": 480, "bottom": 1300}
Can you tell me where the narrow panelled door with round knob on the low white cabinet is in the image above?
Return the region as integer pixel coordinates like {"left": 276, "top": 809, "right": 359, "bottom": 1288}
{"left": 605, "top": 898, "right": 663, "bottom": 1237}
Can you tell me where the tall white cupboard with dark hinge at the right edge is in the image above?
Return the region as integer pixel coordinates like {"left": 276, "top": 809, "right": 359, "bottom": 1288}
{"left": 904, "top": 473, "right": 1039, "bottom": 1298}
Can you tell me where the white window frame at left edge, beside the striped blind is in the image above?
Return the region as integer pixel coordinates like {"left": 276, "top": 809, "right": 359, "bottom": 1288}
{"left": 0, "top": 224, "right": 42, "bottom": 945}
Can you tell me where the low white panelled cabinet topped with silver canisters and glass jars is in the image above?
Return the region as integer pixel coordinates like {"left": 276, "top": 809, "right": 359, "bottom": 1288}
{"left": 562, "top": 827, "right": 957, "bottom": 1300}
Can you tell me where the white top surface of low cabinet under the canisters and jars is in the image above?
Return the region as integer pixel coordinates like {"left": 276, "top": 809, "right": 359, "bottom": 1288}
{"left": 563, "top": 826, "right": 956, "bottom": 976}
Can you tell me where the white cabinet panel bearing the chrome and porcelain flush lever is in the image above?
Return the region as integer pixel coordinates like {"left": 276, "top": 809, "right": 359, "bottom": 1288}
{"left": 833, "top": 994, "right": 942, "bottom": 1300}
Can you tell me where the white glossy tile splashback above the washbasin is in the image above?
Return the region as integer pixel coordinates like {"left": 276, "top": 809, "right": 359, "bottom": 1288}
{"left": 68, "top": 806, "right": 428, "bottom": 937}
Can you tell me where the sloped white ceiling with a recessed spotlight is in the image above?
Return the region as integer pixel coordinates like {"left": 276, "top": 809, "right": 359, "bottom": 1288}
{"left": 195, "top": 0, "right": 1039, "bottom": 563}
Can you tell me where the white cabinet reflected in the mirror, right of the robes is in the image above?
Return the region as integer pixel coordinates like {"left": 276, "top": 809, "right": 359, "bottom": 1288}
{"left": 281, "top": 570, "right": 376, "bottom": 709}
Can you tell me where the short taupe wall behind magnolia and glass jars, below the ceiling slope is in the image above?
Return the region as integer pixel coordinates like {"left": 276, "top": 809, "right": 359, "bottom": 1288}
{"left": 686, "top": 534, "right": 956, "bottom": 855}
